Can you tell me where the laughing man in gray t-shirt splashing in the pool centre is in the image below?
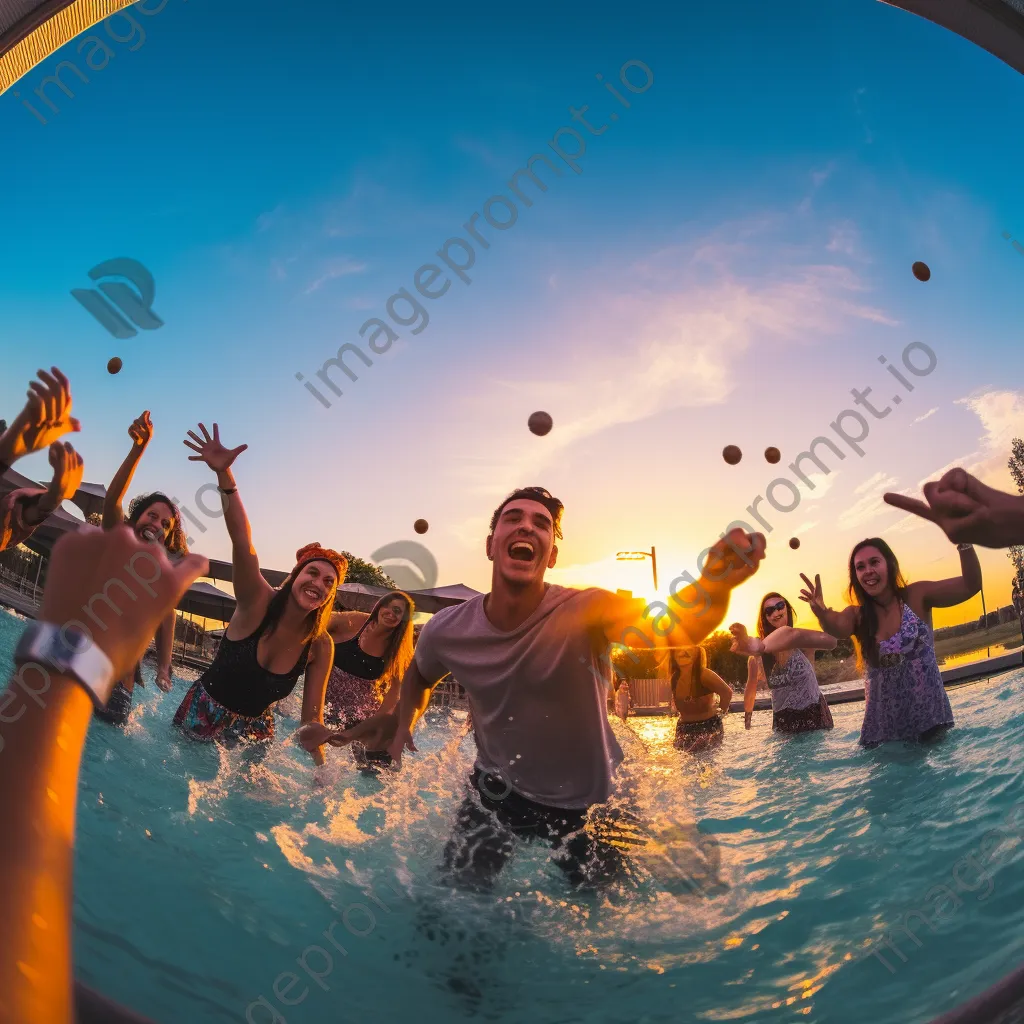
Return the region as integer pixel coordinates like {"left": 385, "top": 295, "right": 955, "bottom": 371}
{"left": 334, "top": 487, "right": 765, "bottom": 886}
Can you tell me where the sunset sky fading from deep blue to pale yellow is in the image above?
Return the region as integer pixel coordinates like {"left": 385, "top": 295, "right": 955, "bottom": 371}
{"left": 0, "top": 0, "right": 1024, "bottom": 618}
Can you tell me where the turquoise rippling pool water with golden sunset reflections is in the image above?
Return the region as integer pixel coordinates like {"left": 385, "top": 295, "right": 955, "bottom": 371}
{"left": 0, "top": 613, "right": 1024, "bottom": 1024}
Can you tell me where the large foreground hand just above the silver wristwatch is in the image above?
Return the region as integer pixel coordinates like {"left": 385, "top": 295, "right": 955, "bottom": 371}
{"left": 39, "top": 526, "right": 209, "bottom": 679}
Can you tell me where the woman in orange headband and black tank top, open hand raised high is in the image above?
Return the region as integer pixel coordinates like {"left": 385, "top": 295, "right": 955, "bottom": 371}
{"left": 174, "top": 423, "right": 348, "bottom": 765}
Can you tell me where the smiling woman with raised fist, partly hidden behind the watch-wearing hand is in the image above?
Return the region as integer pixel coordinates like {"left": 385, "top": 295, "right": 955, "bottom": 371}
{"left": 96, "top": 411, "right": 188, "bottom": 725}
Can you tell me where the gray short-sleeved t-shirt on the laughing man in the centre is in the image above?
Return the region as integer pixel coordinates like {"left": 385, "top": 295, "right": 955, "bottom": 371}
{"left": 416, "top": 584, "right": 623, "bottom": 809}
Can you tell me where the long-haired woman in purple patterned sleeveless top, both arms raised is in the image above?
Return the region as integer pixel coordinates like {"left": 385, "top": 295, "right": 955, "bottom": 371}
{"left": 800, "top": 537, "right": 981, "bottom": 746}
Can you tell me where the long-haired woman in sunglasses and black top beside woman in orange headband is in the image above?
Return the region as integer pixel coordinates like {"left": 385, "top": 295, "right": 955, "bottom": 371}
{"left": 324, "top": 590, "right": 416, "bottom": 764}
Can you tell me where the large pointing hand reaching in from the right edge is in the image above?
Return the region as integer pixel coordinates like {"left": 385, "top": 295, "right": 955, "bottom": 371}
{"left": 884, "top": 467, "right": 1024, "bottom": 548}
